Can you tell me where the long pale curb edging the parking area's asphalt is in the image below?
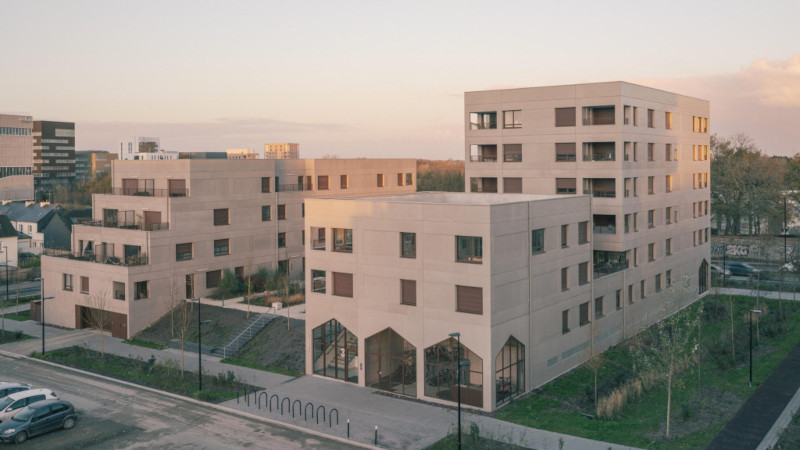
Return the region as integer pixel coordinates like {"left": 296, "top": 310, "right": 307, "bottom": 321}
{"left": 0, "top": 350, "right": 381, "bottom": 450}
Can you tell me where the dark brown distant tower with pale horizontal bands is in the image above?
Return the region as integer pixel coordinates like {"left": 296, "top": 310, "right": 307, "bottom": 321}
{"left": 33, "top": 120, "right": 75, "bottom": 200}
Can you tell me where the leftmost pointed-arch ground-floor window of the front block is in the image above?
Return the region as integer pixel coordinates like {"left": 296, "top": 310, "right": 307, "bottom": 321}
{"left": 312, "top": 319, "right": 358, "bottom": 383}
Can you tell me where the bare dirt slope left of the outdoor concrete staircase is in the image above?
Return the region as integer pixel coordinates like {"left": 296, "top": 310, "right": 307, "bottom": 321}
{"left": 136, "top": 305, "right": 247, "bottom": 347}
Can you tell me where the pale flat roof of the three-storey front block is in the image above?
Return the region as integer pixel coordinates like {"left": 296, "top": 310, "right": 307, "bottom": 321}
{"left": 318, "top": 192, "right": 580, "bottom": 205}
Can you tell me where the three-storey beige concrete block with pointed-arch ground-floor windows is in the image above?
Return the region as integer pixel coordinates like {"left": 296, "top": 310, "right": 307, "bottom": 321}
{"left": 306, "top": 192, "right": 591, "bottom": 410}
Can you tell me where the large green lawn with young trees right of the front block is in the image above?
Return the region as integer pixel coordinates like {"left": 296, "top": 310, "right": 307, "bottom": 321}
{"left": 496, "top": 296, "right": 800, "bottom": 448}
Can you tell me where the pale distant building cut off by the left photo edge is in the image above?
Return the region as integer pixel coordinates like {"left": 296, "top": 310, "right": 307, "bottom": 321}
{"left": 0, "top": 114, "right": 33, "bottom": 200}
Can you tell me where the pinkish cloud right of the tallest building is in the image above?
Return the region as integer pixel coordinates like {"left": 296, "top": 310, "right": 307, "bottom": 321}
{"left": 632, "top": 54, "right": 800, "bottom": 156}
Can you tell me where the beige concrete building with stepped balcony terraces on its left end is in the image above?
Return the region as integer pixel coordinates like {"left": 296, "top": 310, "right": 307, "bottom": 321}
{"left": 42, "top": 159, "right": 416, "bottom": 338}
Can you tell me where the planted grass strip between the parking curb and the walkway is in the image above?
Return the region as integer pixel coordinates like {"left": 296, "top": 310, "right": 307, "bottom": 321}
{"left": 31, "top": 346, "right": 261, "bottom": 403}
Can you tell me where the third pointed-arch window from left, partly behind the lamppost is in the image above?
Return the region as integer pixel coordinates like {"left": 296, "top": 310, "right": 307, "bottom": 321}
{"left": 425, "top": 338, "right": 483, "bottom": 408}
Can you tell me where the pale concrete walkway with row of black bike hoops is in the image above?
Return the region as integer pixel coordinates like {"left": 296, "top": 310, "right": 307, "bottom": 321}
{"left": 0, "top": 316, "right": 629, "bottom": 450}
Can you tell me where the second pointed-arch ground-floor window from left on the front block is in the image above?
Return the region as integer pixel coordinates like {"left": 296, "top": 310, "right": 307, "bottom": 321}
{"left": 364, "top": 328, "right": 417, "bottom": 397}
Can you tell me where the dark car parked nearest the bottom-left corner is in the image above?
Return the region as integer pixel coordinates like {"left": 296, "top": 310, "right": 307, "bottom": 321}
{"left": 0, "top": 400, "right": 78, "bottom": 444}
